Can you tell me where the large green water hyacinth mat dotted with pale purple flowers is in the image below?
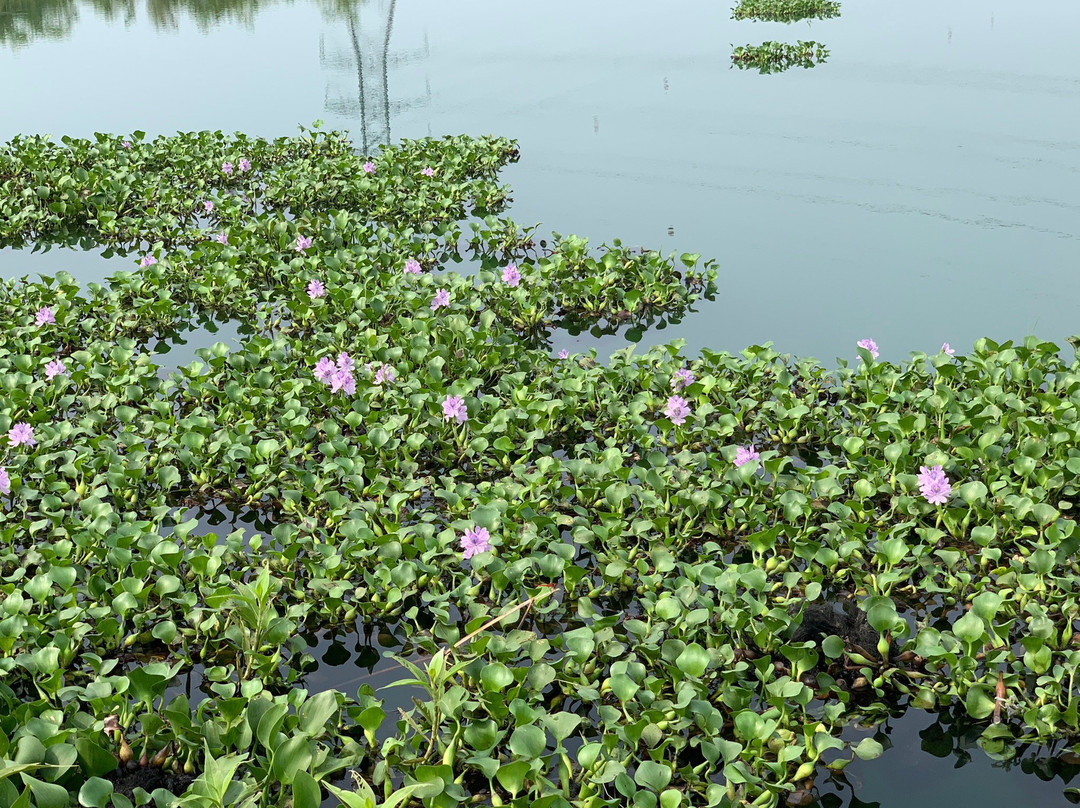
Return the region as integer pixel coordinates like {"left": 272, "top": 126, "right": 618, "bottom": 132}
{"left": 0, "top": 131, "right": 1080, "bottom": 808}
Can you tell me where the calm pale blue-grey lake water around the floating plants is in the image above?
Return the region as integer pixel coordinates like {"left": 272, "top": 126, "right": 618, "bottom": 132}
{"left": 0, "top": 0, "right": 1080, "bottom": 808}
